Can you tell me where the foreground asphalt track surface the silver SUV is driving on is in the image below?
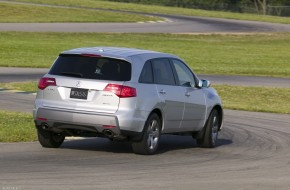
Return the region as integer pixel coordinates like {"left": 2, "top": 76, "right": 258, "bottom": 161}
{"left": 0, "top": 111, "right": 290, "bottom": 190}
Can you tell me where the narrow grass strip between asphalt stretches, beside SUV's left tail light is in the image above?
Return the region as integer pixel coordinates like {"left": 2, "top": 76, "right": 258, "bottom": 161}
{"left": 0, "top": 81, "right": 38, "bottom": 92}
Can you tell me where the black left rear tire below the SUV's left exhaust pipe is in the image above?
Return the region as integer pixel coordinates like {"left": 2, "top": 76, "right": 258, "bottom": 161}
{"left": 37, "top": 129, "right": 65, "bottom": 148}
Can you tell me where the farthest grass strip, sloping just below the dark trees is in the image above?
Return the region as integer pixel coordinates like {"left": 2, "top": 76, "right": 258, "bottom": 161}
{"left": 10, "top": 0, "right": 290, "bottom": 24}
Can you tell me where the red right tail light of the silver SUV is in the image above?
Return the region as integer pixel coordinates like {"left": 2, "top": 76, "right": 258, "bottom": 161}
{"left": 104, "top": 84, "right": 137, "bottom": 98}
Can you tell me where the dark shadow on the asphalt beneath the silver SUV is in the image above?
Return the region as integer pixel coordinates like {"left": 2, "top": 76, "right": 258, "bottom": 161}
{"left": 60, "top": 135, "right": 232, "bottom": 154}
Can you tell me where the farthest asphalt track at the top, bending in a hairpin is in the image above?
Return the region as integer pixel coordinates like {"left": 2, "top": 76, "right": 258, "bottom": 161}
{"left": 0, "top": 0, "right": 290, "bottom": 33}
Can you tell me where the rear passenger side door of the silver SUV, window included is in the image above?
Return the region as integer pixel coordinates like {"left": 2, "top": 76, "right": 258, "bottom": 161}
{"left": 151, "top": 58, "right": 184, "bottom": 132}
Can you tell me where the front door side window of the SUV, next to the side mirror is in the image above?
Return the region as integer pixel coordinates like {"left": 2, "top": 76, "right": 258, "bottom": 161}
{"left": 172, "top": 59, "right": 195, "bottom": 87}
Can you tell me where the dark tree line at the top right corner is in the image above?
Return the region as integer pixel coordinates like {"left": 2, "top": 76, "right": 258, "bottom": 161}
{"left": 108, "top": 0, "right": 290, "bottom": 16}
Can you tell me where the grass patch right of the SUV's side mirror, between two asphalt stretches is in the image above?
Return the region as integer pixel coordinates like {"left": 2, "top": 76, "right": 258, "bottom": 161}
{"left": 214, "top": 85, "right": 290, "bottom": 114}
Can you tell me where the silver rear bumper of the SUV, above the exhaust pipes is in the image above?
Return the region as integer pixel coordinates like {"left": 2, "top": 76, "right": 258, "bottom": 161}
{"left": 33, "top": 108, "right": 146, "bottom": 136}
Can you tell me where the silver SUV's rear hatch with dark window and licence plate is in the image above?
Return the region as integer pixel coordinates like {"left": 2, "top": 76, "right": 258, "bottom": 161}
{"left": 39, "top": 54, "right": 131, "bottom": 113}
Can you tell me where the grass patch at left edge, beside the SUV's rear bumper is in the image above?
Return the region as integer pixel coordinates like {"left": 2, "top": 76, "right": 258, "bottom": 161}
{"left": 0, "top": 111, "right": 37, "bottom": 142}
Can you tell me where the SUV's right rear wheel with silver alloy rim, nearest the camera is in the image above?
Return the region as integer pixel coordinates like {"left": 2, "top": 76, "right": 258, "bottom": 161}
{"left": 132, "top": 113, "right": 161, "bottom": 155}
